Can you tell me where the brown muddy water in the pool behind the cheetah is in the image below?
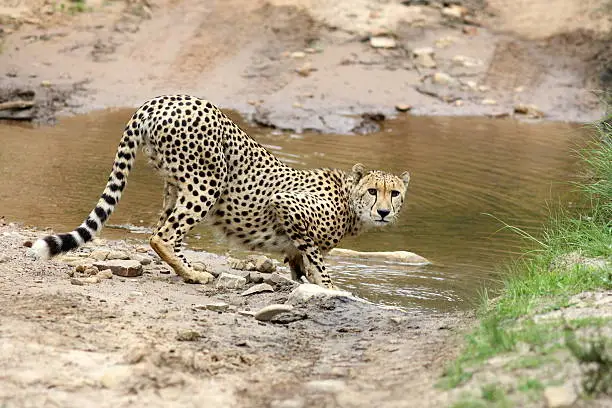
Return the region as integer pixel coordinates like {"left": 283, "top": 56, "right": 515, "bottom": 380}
{"left": 0, "top": 109, "right": 587, "bottom": 310}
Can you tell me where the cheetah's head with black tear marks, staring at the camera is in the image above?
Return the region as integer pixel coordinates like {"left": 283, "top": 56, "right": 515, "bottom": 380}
{"left": 347, "top": 163, "right": 410, "bottom": 227}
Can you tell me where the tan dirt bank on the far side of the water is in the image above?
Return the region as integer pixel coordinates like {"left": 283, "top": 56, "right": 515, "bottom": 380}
{"left": 0, "top": 0, "right": 612, "bottom": 133}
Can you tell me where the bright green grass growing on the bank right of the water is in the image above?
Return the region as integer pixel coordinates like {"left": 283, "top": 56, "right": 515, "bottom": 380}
{"left": 440, "top": 115, "right": 612, "bottom": 392}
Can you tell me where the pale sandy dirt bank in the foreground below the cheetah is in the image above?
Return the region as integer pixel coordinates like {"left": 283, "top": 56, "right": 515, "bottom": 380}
{"left": 0, "top": 224, "right": 469, "bottom": 407}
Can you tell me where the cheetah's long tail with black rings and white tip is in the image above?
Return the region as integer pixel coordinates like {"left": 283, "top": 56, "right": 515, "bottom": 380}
{"left": 30, "top": 115, "right": 146, "bottom": 259}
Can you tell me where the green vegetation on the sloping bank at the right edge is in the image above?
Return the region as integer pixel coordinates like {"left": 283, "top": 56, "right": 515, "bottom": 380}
{"left": 440, "top": 115, "right": 612, "bottom": 400}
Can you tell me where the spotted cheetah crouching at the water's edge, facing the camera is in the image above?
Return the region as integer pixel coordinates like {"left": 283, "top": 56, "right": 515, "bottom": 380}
{"left": 31, "top": 95, "right": 410, "bottom": 288}
